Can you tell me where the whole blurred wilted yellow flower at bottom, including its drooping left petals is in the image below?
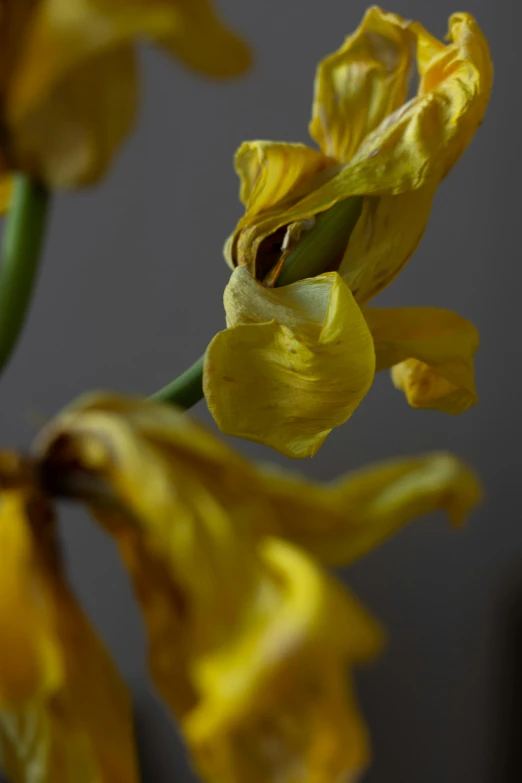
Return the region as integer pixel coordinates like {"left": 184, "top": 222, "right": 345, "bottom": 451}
{"left": 0, "top": 395, "right": 480, "bottom": 783}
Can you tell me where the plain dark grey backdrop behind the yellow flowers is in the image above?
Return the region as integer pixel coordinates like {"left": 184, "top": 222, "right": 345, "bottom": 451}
{"left": 0, "top": 0, "right": 522, "bottom": 783}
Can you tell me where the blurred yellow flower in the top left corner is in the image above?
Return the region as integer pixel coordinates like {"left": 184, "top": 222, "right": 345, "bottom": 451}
{"left": 0, "top": 0, "right": 250, "bottom": 187}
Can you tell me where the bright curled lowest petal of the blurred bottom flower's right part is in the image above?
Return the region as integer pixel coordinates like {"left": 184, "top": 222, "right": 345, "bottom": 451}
{"left": 185, "top": 539, "right": 382, "bottom": 783}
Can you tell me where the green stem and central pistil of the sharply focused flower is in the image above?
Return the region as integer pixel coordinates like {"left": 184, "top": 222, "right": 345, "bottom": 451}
{"left": 152, "top": 196, "right": 362, "bottom": 410}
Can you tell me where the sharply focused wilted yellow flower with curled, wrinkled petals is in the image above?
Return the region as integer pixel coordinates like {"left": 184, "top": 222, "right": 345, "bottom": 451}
{"left": 204, "top": 7, "right": 492, "bottom": 457}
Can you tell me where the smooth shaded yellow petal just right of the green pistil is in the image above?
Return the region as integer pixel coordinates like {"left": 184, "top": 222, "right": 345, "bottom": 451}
{"left": 339, "top": 185, "right": 437, "bottom": 303}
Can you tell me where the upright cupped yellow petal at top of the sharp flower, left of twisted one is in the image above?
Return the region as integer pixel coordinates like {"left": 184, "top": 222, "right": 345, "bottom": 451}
{"left": 310, "top": 7, "right": 412, "bottom": 163}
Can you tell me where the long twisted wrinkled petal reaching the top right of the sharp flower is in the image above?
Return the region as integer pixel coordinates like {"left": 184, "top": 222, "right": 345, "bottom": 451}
{"left": 230, "top": 14, "right": 492, "bottom": 276}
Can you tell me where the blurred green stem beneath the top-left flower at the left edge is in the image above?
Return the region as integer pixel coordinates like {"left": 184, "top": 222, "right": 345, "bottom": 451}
{"left": 0, "top": 175, "right": 49, "bottom": 373}
